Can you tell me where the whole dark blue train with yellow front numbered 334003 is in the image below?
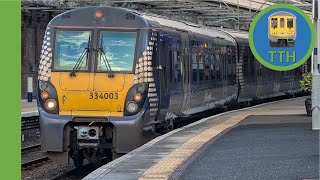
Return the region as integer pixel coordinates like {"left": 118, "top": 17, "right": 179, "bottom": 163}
{"left": 37, "top": 6, "right": 306, "bottom": 166}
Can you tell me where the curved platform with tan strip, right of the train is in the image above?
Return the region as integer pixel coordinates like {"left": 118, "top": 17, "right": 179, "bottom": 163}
{"left": 84, "top": 97, "right": 319, "bottom": 180}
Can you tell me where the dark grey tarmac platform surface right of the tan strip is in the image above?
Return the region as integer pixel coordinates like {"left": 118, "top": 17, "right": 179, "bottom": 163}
{"left": 179, "top": 115, "right": 319, "bottom": 180}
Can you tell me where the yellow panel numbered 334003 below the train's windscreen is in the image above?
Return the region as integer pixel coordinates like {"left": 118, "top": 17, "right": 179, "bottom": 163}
{"left": 51, "top": 72, "right": 134, "bottom": 116}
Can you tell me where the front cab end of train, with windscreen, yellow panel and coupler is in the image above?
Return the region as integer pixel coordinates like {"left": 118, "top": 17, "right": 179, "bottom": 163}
{"left": 38, "top": 7, "right": 156, "bottom": 166}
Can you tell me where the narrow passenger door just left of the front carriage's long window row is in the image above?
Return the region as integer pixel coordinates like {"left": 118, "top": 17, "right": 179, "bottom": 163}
{"left": 181, "top": 33, "right": 191, "bottom": 112}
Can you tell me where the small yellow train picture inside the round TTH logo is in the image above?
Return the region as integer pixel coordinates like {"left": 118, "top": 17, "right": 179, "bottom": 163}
{"left": 268, "top": 11, "right": 297, "bottom": 47}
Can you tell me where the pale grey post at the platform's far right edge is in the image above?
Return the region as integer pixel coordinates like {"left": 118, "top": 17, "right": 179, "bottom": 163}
{"left": 311, "top": 0, "right": 320, "bottom": 130}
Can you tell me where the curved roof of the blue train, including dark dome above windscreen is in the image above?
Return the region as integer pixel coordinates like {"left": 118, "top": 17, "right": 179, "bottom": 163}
{"left": 49, "top": 6, "right": 248, "bottom": 42}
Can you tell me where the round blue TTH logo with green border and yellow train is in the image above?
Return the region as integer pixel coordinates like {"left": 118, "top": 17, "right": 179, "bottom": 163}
{"left": 249, "top": 4, "right": 316, "bottom": 71}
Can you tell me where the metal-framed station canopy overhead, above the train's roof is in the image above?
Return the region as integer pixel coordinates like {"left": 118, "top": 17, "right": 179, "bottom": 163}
{"left": 21, "top": 0, "right": 312, "bottom": 30}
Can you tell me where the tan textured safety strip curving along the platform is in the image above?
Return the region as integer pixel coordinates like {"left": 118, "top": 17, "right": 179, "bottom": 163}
{"left": 139, "top": 113, "right": 252, "bottom": 180}
